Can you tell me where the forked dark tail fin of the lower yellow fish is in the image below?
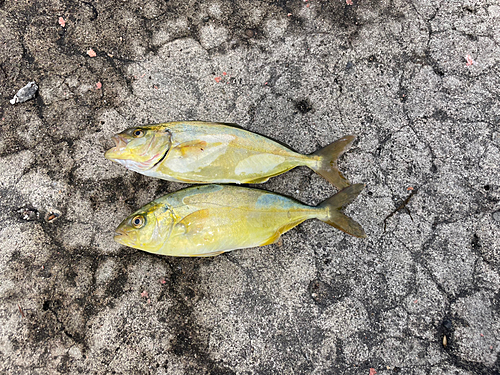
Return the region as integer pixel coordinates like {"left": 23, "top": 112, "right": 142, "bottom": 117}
{"left": 318, "top": 184, "right": 366, "bottom": 238}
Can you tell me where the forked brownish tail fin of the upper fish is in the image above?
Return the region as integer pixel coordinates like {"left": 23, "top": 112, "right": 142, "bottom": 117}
{"left": 311, "top": 135, "right": 356, "bottom": 190}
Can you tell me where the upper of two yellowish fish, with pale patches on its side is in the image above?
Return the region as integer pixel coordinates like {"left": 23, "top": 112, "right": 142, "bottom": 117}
{"left": 105, "top": 121, "right": 355, "bottom": 190}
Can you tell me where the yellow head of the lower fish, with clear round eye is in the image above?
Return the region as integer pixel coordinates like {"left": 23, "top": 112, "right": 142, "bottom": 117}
{"left": 114, "top": 202, "right": 174, "bottom": 253}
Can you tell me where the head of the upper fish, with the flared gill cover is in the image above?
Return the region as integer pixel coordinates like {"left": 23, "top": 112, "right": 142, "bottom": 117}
{"left": 104, "top": 125, "right": 172, "bottom": 173}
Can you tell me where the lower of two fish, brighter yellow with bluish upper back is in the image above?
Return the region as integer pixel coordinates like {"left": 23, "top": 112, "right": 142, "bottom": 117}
{"left": 114, "top": 184, "right": 366, "bottom": 257}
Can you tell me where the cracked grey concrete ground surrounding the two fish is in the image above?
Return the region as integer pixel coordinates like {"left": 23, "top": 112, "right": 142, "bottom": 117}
{"left": 0, "top": 0, "right": 500, "bottom": 375}
